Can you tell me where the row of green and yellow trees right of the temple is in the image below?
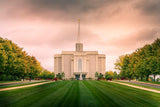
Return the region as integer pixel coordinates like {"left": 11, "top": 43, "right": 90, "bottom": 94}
{"left": 115, "top": 38, "right": 160, "bottom": 81}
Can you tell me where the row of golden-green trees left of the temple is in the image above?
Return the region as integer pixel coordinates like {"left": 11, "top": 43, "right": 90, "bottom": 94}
{"left": 0, "top": 38, "right": 54, "bottom": 81}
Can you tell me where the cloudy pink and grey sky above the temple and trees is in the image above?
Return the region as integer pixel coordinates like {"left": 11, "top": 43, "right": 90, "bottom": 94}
{"left": 0, "top": 0, "right": 160, "bottom": 71}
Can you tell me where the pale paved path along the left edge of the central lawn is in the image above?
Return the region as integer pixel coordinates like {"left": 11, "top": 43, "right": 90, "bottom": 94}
{"left": 0, "top": 81, "right": 53, "bottom": 91}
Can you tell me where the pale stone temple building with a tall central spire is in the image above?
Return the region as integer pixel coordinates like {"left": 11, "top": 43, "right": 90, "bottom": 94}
{"left": 54, "top": 21, "right": 106, "bottom": 80}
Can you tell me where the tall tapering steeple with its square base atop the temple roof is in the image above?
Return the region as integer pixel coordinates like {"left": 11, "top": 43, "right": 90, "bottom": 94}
{"left": 76, "top": 19, "right": 83, "bottom": 52}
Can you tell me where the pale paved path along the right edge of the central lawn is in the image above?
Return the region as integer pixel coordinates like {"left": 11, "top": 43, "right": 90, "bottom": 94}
{"left": 110, "top": 81, "right": 160, "bottom": 93}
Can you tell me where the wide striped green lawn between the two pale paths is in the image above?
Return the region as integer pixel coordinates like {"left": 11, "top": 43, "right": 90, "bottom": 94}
{"left": 0, "top": 81, "right": 160, "bottom": 107}
